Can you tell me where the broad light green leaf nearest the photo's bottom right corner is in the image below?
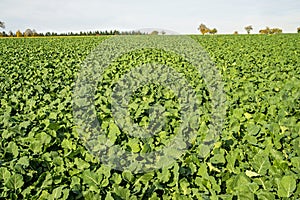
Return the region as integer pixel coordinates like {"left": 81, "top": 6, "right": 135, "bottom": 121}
{"left": 278, "top": 176, "right": 296, "bottom": 197}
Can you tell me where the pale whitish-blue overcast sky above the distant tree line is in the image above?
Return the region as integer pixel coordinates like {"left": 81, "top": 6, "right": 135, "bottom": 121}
{"left": 0, "top": 0, "right": 300, "bottom": 34}
